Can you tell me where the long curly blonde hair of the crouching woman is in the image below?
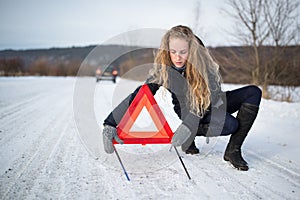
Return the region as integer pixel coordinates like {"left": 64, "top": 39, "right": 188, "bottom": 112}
{"left": 150, "top": 25, "right": 221, "bottom": 116}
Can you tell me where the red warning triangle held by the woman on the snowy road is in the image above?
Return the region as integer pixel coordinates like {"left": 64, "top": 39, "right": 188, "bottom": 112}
{"left": 114, "top": 84, "right": 173, "bottom": 145}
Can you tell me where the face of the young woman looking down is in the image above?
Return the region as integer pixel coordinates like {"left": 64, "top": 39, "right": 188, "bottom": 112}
{"left": 169, "top": 38, "right": 189, "bottom": 68}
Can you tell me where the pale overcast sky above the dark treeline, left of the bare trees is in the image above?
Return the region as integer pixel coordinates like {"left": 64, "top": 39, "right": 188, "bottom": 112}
{"left": 0, "top": 0, "right": 233, "bottom": 50}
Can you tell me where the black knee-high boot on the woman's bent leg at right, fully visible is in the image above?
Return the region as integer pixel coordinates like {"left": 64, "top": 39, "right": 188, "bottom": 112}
{"left": 224, "top": 103, "right": 258, "bottom": 171}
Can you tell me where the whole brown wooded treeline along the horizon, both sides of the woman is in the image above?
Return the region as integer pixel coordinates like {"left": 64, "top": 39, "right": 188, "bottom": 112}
{"left": 0, "top": 45, "right": 300, "bottom": 86}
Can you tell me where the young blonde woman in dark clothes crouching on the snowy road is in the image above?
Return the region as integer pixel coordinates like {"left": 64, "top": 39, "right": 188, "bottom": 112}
{"left": 103, "top": 25, "right": 261, "bottom": 170}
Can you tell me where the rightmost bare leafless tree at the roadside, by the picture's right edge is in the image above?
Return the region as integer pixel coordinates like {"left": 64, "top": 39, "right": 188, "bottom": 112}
{"left": 263, "top": 0, "right": 299, "bottom": 98}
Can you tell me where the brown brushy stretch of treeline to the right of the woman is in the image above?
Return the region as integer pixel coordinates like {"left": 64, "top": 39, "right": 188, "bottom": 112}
{"left": 211, "top": 46, "right": 300, "bottom": 86}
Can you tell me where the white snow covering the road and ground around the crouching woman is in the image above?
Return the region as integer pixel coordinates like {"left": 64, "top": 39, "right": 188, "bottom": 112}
{"left": 0, "top": 77, "right": 300, "bottom": 199}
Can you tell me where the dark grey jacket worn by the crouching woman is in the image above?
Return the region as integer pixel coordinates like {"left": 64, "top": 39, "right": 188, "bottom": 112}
{"left": 104, "top": 67, "right": 224, "bottom": 137}
